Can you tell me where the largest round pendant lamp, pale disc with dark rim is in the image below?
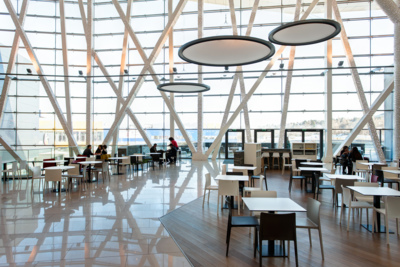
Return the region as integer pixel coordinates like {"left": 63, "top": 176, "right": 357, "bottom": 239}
{"left": 178, "top": 35, "right": 275, "bottom": 67}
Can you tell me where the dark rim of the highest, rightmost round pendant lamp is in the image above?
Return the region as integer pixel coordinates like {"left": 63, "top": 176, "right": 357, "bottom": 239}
{"left": 268, "top": 19, "right": 342, "bottom": 46}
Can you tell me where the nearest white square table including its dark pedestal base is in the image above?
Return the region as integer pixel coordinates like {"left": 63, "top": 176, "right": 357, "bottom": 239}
{"left": 242, "top": 197, "right": 307, "bottom": 257}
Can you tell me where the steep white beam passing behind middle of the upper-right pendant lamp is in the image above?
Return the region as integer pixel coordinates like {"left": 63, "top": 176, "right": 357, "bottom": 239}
{"left": 278, "top": 0, "right": 301, "bottom": 148}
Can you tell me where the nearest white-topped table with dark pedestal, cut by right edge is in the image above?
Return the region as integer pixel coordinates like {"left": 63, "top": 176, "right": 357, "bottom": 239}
{"left": 348, "top": 186, "right": 400, "bottom": 233}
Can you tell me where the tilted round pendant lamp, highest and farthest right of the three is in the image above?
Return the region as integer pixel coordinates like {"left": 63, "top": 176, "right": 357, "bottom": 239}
{"left": 269, "top": 19, "right": 342, "bottom": 46}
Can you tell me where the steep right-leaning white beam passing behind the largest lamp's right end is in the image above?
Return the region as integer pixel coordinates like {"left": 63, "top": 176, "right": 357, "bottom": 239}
{"left": 212, "top": 0, "right": 260, "bottom": 160}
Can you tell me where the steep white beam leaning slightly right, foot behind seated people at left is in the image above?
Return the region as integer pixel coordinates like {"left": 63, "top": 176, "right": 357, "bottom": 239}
{"left": 112, "top": 0, "right": 133, "bottom": 155}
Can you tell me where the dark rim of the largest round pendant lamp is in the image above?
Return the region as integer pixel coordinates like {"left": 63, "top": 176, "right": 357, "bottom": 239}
{"left": 178, "top": 35, "right": 275, "bottom": 67}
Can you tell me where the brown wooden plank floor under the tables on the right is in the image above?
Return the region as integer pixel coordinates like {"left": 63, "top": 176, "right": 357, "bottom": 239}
{"left": 160, "top": 171, "right": 400, "bottom": 267}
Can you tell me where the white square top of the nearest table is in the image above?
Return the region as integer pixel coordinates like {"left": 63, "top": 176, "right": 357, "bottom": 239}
{"left": 242, "top": 197, "right": 306, "bottom": 212}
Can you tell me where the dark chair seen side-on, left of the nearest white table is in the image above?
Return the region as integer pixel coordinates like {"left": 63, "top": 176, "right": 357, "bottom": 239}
{"left": 226, "top": 201, "right": 259, "bottom": 257}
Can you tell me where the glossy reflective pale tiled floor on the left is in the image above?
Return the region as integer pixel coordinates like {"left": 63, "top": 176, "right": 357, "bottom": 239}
{"left": 0, "top": 160, "right": 217, "bottom": 266}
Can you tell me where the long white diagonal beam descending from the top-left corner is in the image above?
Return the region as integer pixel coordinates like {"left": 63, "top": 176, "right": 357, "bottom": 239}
{"left": 4, "top": 0, "right": 79, "bottom": 153}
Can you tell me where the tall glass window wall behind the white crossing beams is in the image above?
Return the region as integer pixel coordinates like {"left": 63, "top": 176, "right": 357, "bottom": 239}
{"left": 0, "top": 0, "right": 393, "bottom": 160}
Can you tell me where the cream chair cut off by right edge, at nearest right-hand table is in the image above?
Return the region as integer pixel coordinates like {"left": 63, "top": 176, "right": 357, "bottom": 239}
{"left": 372, "top": 197, "right": 400, "bottom": 245}
